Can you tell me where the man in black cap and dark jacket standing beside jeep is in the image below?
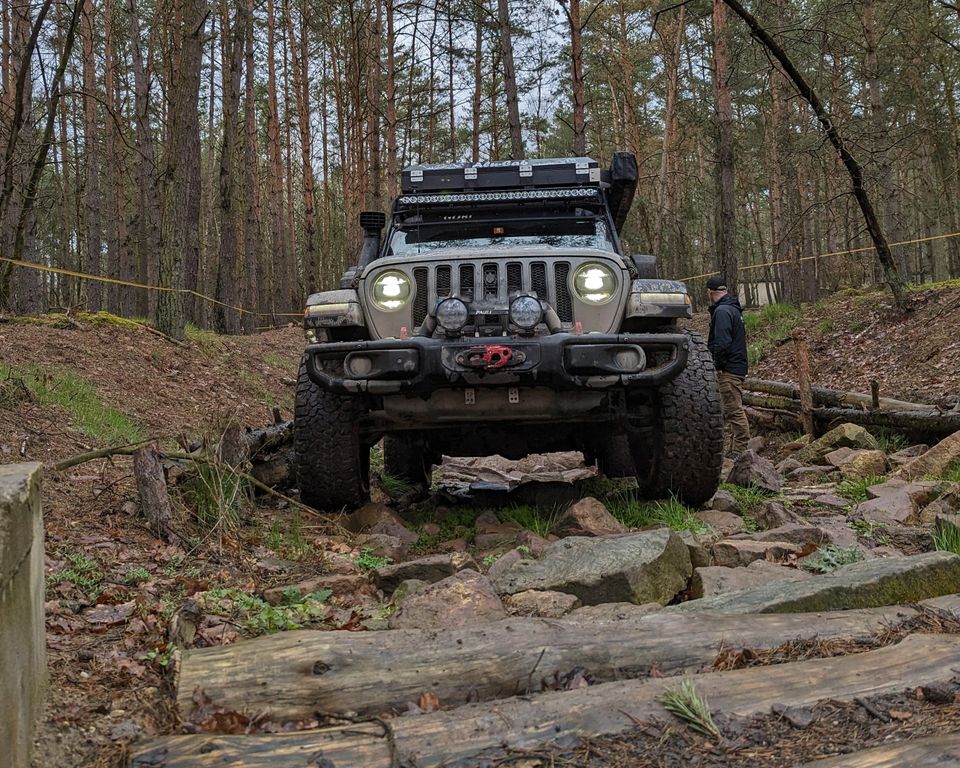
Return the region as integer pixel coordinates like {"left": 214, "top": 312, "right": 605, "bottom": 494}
{"left": 707, "top": 277, "right": 750, "bottom": 458}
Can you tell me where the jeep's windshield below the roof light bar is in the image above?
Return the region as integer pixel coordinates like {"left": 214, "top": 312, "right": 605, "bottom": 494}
{"left": 388, "top": 216, "right": 614, "bottom": 256}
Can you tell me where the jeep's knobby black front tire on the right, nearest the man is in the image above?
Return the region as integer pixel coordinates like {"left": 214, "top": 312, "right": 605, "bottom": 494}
{"left": 634, "top": 331, "right": 723, "bottom": 506}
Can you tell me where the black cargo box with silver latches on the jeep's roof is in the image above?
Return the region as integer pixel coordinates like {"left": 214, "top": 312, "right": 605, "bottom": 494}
{"left": 400, "top": 157, "right": 601, "bottom": 194}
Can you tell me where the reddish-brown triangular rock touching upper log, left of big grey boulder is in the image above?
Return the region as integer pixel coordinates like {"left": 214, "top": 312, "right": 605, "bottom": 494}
{"left": 390, "top": 570, "right": 507, "bottom": 629}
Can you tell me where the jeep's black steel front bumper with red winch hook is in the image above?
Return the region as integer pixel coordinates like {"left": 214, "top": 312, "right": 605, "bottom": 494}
{"left": 306, "top": 333, "right": 688, "bottom": 395}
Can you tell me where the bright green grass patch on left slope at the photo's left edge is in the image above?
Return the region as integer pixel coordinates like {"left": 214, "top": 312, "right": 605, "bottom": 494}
{"left": 0, "top": 363, "right": 146, "bottom": 445}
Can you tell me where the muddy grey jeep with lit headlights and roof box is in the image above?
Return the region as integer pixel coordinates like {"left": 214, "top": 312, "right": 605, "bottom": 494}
{"left": 294, "top": 152, "right": 723, "bottom": 510}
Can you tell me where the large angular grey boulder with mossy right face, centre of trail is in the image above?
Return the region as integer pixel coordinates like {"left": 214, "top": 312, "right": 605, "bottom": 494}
{"left": 494, "top": 528, "right": 692, "bottom": 605}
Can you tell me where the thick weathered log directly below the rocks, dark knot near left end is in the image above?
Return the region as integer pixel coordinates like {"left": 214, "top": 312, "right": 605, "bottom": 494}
{"left": 177, "top": 606, "right": 916, "bottom": 720}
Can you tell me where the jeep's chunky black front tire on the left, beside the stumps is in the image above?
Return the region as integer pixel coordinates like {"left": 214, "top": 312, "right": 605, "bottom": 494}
{"left": 293, "top": 359, "right": 370, "bottom": 512}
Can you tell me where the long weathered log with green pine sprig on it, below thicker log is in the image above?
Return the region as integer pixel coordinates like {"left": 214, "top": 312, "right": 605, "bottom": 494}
{"left": 132, "top": 636, "right": 960, "bottom": 768}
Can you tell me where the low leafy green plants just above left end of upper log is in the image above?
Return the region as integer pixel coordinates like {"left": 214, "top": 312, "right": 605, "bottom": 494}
{"left": 202, "top": 588, "right": 332, "bottom": 636}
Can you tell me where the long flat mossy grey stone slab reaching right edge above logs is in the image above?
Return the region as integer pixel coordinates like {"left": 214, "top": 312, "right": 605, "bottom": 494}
{"left": 664, "top": 552, "right": 960, "bottom": 614}
